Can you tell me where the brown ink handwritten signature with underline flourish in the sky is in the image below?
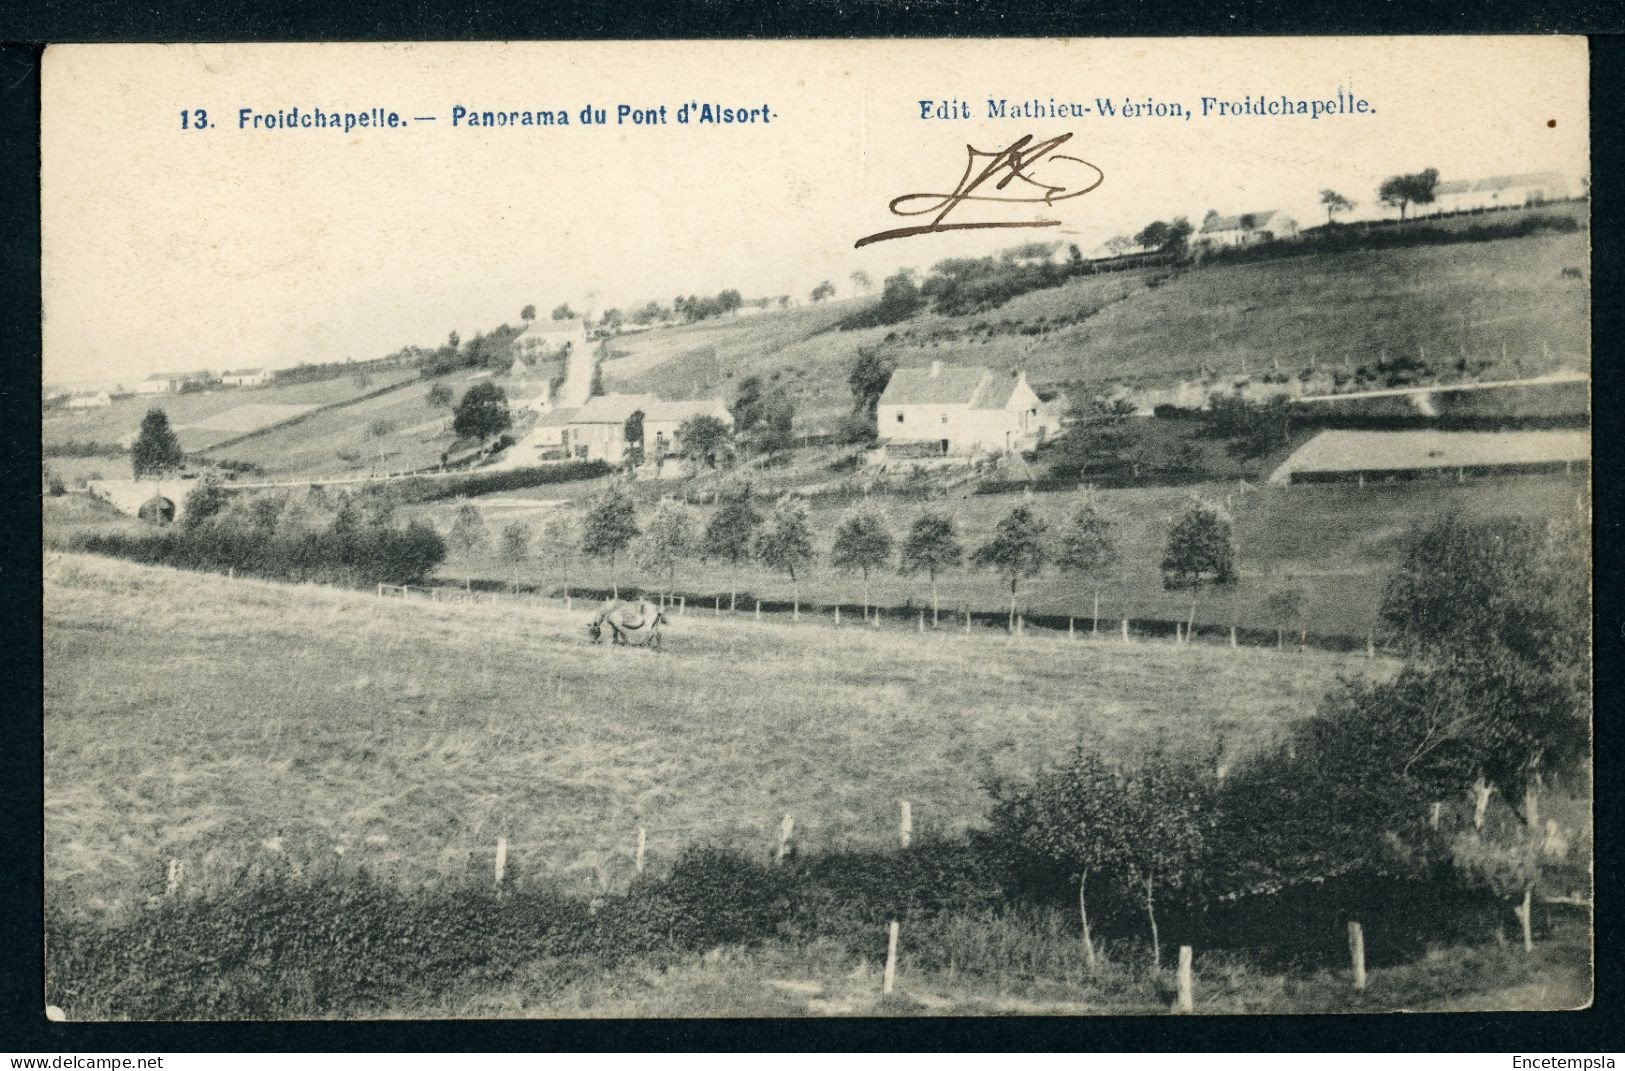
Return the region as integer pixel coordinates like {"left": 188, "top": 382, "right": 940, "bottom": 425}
{"left": 853, "top": 133, "right": 1105, "bottom": 249}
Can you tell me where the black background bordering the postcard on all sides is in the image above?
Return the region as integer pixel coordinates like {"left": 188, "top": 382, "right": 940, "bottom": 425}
{"left": 0, "top": 0, "right": 1625, "bottom": 1053}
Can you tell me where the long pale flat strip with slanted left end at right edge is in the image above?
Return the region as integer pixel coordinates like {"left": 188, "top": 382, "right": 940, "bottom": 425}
{"left": 1269, "top": 429, "right": 1591, "bottom": 483}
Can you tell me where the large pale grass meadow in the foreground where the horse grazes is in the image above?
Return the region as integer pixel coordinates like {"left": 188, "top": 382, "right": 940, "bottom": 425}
{"left": 46, "top": 554, "right": 1393, "bottom": 907}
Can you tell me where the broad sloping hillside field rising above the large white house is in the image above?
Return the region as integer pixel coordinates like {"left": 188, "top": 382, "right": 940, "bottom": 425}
{"left": 605, "top": 231, "right": 1589, "bottom": 429}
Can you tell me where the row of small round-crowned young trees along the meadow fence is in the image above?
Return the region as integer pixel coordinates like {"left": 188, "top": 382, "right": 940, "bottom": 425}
{"left": 449, "top": 483, "right": 1237, "bottom": 627}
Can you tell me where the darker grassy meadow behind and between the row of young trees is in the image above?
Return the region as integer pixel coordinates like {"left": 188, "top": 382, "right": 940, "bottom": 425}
{"left": 424, "top": 476, "right": 1586, "bottom": 637}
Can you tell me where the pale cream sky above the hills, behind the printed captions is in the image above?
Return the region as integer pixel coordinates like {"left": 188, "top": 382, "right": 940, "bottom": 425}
{"left": 42, "top": 37, "right": 1589, "bottom": 390}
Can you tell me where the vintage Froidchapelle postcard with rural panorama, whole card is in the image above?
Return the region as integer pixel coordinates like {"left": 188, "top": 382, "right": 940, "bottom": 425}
{"left": 41, "top": 37, "right": 1593, "bottom": 1021}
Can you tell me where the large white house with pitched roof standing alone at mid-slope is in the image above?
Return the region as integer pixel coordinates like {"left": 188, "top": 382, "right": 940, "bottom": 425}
{"left": 876, "top": 361, "right": 1061, "bottom": 453}
